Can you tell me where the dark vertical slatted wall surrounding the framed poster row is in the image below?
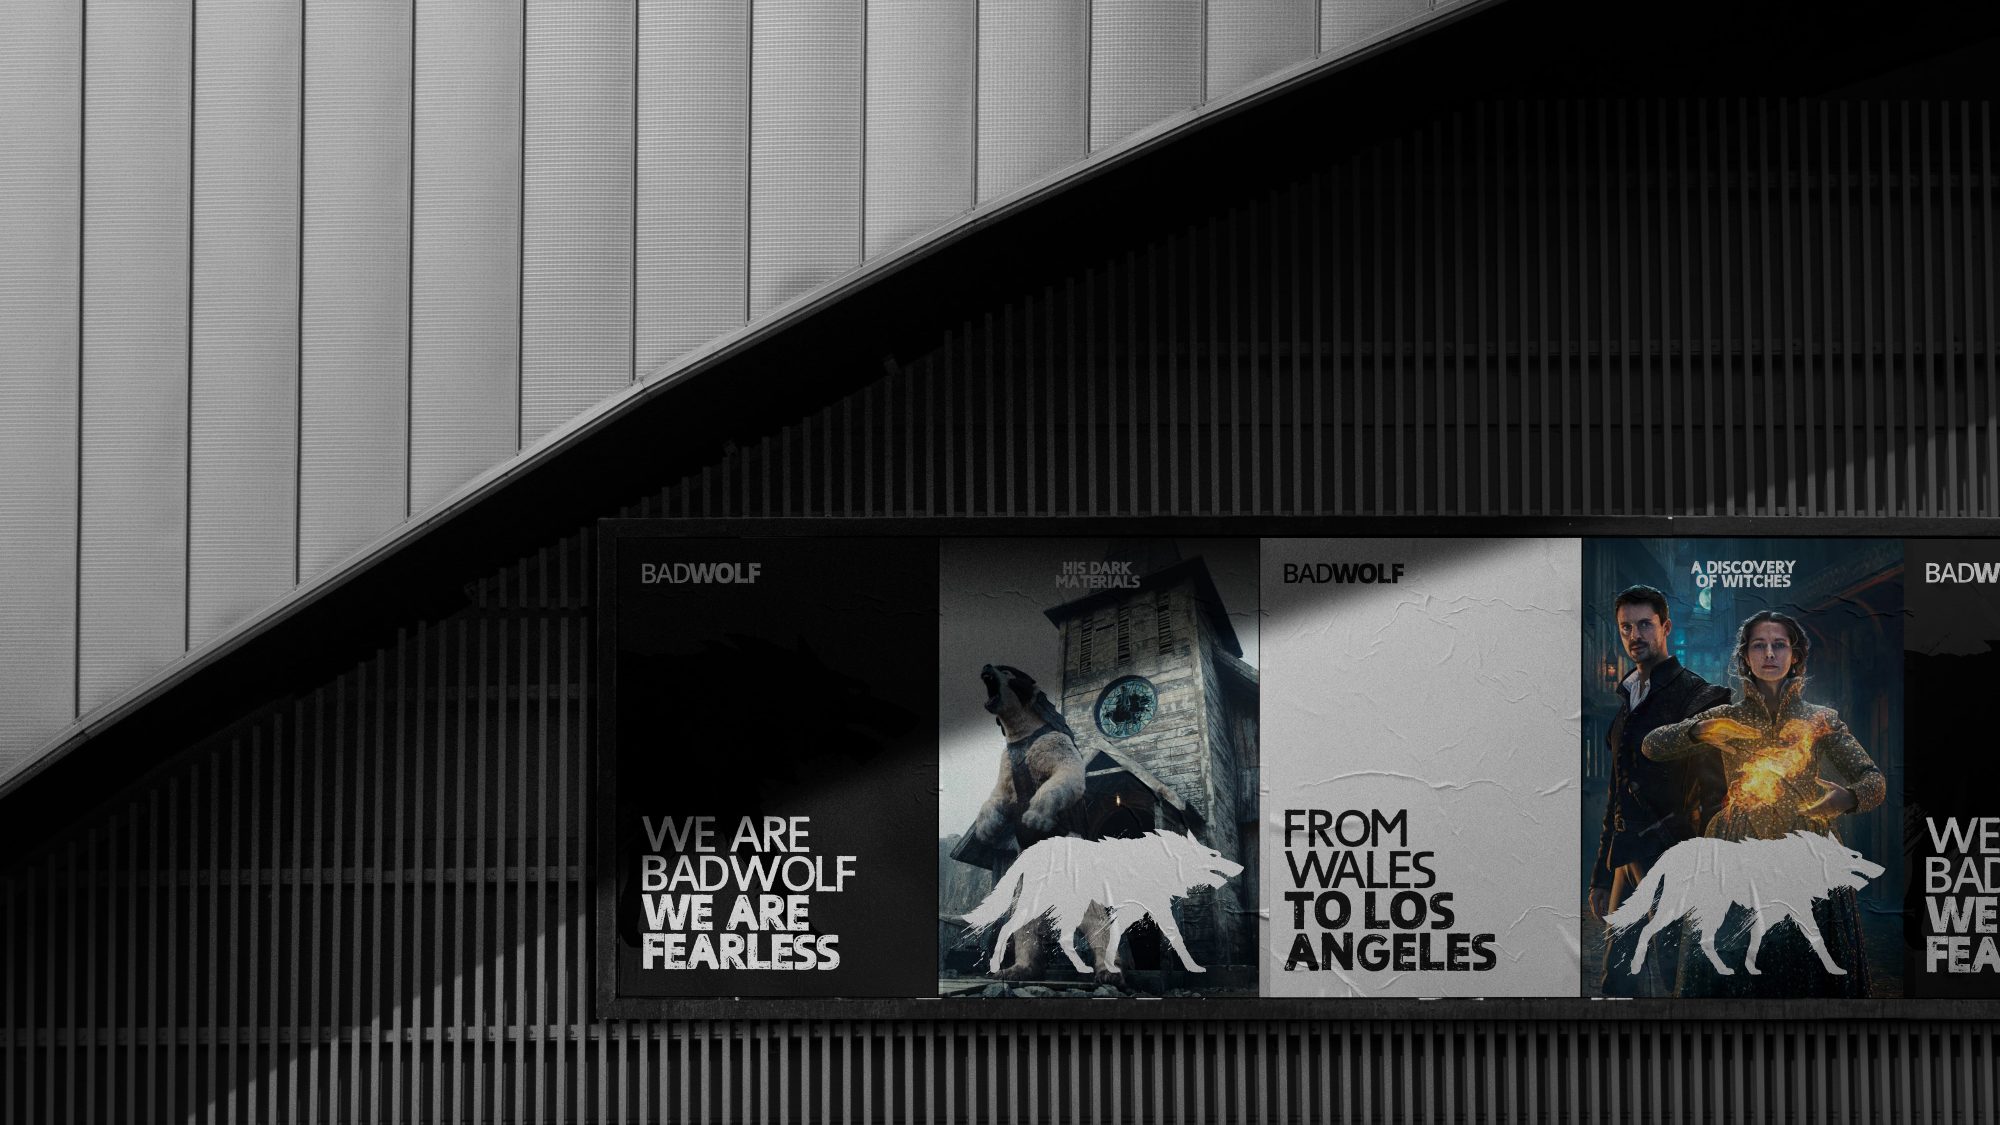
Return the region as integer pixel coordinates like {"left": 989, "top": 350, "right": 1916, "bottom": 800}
{"left": 0, "top": 102, "right": 2000, "bottom": 1123}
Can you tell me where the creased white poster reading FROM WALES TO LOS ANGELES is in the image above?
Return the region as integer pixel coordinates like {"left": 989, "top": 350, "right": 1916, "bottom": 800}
{"left": 1260, "top": 538, "right": 1582, "bottom": 997}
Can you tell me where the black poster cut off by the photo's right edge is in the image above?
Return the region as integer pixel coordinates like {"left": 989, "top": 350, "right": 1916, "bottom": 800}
{"left": 1904, "top": 538, "right": 2000, "bottom": 997}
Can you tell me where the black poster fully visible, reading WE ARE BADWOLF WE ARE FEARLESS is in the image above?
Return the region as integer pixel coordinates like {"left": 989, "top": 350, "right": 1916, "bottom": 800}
{"left": 596, "top": 522, "right": 938, "bottom": 1017}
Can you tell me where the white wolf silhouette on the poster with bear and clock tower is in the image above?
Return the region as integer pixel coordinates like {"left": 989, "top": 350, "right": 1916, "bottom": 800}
{"left": 966, "top": 831, "right": 1242, "bottom": 977}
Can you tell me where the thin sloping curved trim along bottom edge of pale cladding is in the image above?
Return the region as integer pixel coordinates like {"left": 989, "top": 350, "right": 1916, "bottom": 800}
{"left": 0, "top": 0, "right": 1502, "bottom": 801}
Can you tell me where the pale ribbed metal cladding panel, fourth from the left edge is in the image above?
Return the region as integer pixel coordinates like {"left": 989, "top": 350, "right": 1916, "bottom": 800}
{"left": 298, "top": 0, "right": 412, "bottom": 579}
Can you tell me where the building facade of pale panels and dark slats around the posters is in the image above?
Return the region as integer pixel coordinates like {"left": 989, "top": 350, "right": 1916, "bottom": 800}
{"left": 0, "top": 0, "right": 2000, "bottom": 1121}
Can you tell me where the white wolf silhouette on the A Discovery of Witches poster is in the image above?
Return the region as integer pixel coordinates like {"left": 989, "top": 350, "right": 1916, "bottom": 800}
{"left": 1604, "top": 831, "right": 1882, "bottom": 977}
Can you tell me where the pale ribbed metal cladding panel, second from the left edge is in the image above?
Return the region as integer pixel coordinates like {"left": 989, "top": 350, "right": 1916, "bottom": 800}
{"left": 78, "top": 0, "right": 194, "bottom": 711}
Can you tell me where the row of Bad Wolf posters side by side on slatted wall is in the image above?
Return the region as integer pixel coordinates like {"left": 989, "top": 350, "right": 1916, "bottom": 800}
{"left": 594, "top": 520, "right": 2000, "bottom": 1000}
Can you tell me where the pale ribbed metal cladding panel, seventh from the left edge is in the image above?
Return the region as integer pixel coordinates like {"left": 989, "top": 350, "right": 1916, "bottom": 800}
{"left": 636, "top": 0, "right": 750, "bottom": 376}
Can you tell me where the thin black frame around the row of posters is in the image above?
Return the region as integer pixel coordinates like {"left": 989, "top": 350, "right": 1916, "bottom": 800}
{"left": 586, "top": 516, "right": 2000, "bottom": 1023}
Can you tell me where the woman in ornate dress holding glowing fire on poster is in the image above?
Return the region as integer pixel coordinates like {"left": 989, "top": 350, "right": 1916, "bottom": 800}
{"left": 1640, "top": 611, "right": 1888, "bottom": 997}
